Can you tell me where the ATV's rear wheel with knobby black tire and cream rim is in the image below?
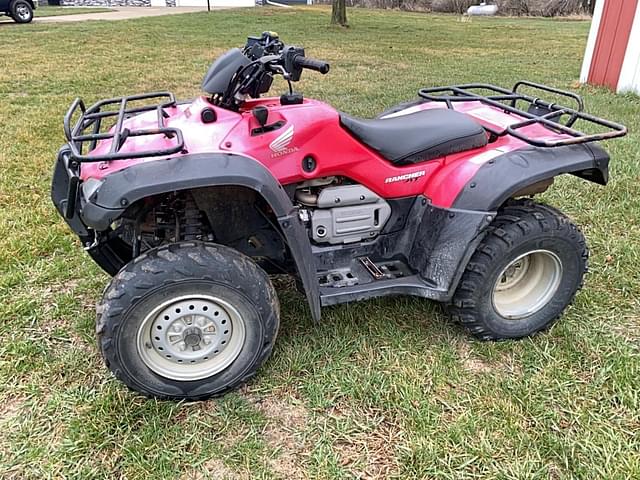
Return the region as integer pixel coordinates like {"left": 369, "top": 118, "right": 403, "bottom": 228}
{"left": 449, "top": 200, "right": 589, "bottom": 340}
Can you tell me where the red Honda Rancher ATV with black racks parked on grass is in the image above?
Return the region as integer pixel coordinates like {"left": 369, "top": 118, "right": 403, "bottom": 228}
{"left": 52, "top": 29, "right": 626, "bottom": 399}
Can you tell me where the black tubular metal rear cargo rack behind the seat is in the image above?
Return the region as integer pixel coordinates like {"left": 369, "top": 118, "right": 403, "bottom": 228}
{"left": 418, "top": 80, "right": 627, "bottom": 147}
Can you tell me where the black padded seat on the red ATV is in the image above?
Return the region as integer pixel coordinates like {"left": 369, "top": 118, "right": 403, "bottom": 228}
{"left": 340, "top": 108, "right": 487, "bottom": 165}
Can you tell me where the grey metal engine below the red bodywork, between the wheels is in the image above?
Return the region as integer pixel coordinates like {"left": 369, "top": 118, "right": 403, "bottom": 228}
{"left": 295, "top": 177, "right": 391, "bottom": 245}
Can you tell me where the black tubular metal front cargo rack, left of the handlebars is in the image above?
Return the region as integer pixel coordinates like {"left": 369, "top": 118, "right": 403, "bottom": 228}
{"left": 64, "top": 92, "right": 184, "bottom": 162}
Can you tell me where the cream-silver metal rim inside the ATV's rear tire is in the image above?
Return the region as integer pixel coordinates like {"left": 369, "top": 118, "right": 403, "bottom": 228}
{"left": 493, "top": 250, "right": 562, "bottom": 320}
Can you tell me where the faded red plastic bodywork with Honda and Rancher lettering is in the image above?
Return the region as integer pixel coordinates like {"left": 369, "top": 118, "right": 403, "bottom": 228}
{"left": 81, "top": 97, "right": 604, "bottom": 212}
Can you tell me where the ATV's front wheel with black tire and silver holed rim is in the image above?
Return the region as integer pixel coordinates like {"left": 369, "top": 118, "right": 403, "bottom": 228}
{"left": 96, "top": 242, "right": 279, "bottom": 400}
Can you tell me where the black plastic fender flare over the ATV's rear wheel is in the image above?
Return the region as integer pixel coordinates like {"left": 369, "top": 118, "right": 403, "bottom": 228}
{"left": 452, "top": 143, "right": 609, "bottom": 211}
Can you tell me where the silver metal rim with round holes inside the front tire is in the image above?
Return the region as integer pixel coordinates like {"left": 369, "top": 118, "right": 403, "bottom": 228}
{"left": 137, "top": 295, "right": 245, "bottom": 381}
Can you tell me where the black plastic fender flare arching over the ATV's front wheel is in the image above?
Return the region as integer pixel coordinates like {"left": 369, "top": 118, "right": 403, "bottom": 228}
{"left": 81, "top": 152, "right": 320, "bottom": 321}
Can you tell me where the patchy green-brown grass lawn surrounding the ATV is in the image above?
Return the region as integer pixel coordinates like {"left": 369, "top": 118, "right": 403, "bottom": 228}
{"left": 0, "top": 8, "right": 640, "bottom": 479}
